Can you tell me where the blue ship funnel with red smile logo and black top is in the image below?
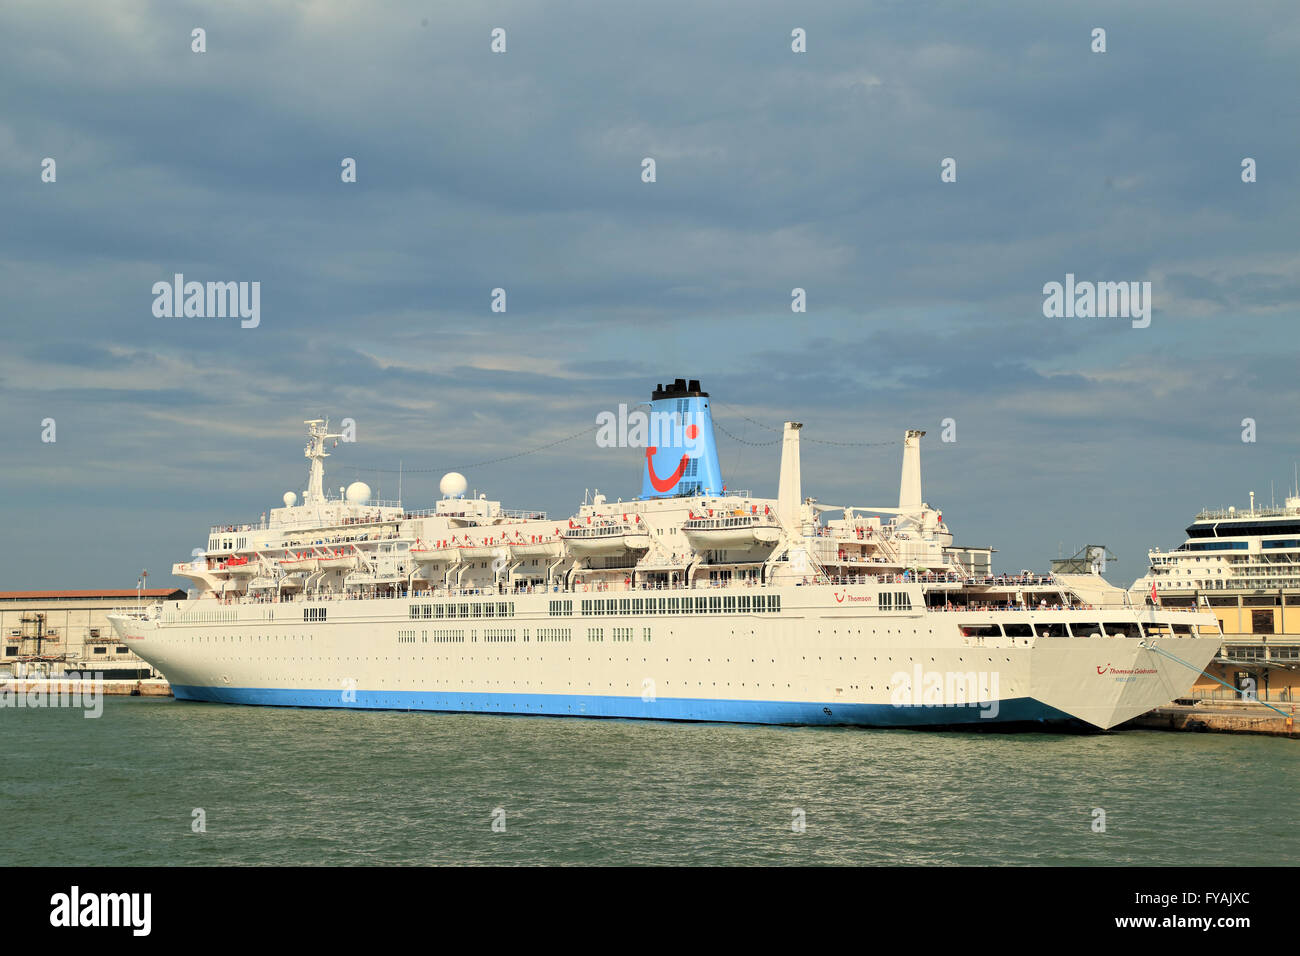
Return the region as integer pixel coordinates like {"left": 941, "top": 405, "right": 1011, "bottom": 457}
{"left": 641, "top": 378, "right": 723, "bottom": 498}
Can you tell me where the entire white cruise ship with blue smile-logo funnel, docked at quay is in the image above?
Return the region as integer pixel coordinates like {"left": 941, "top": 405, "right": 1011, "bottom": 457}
{"left": 111, "top": 378, "right": 1221, "bottom": 730}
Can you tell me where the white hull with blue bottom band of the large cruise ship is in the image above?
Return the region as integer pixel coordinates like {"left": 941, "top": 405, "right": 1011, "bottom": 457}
{"left": 113, "top": 585, "right": 1219, "bottom": 728}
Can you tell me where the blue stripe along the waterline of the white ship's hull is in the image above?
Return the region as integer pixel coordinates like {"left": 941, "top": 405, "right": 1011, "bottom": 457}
{"left": 172, "top": 684, "right": 1078, "bottom": 727}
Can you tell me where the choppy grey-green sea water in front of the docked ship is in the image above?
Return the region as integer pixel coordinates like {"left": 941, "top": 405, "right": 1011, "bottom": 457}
{"left": 0, "top": 697, "right": 1300, "bottom": 865}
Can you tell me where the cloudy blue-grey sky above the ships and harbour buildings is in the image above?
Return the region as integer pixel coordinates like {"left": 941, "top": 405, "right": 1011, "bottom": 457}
{"left": 0, "top": 0, "right": 1300, "bottom": 589}
